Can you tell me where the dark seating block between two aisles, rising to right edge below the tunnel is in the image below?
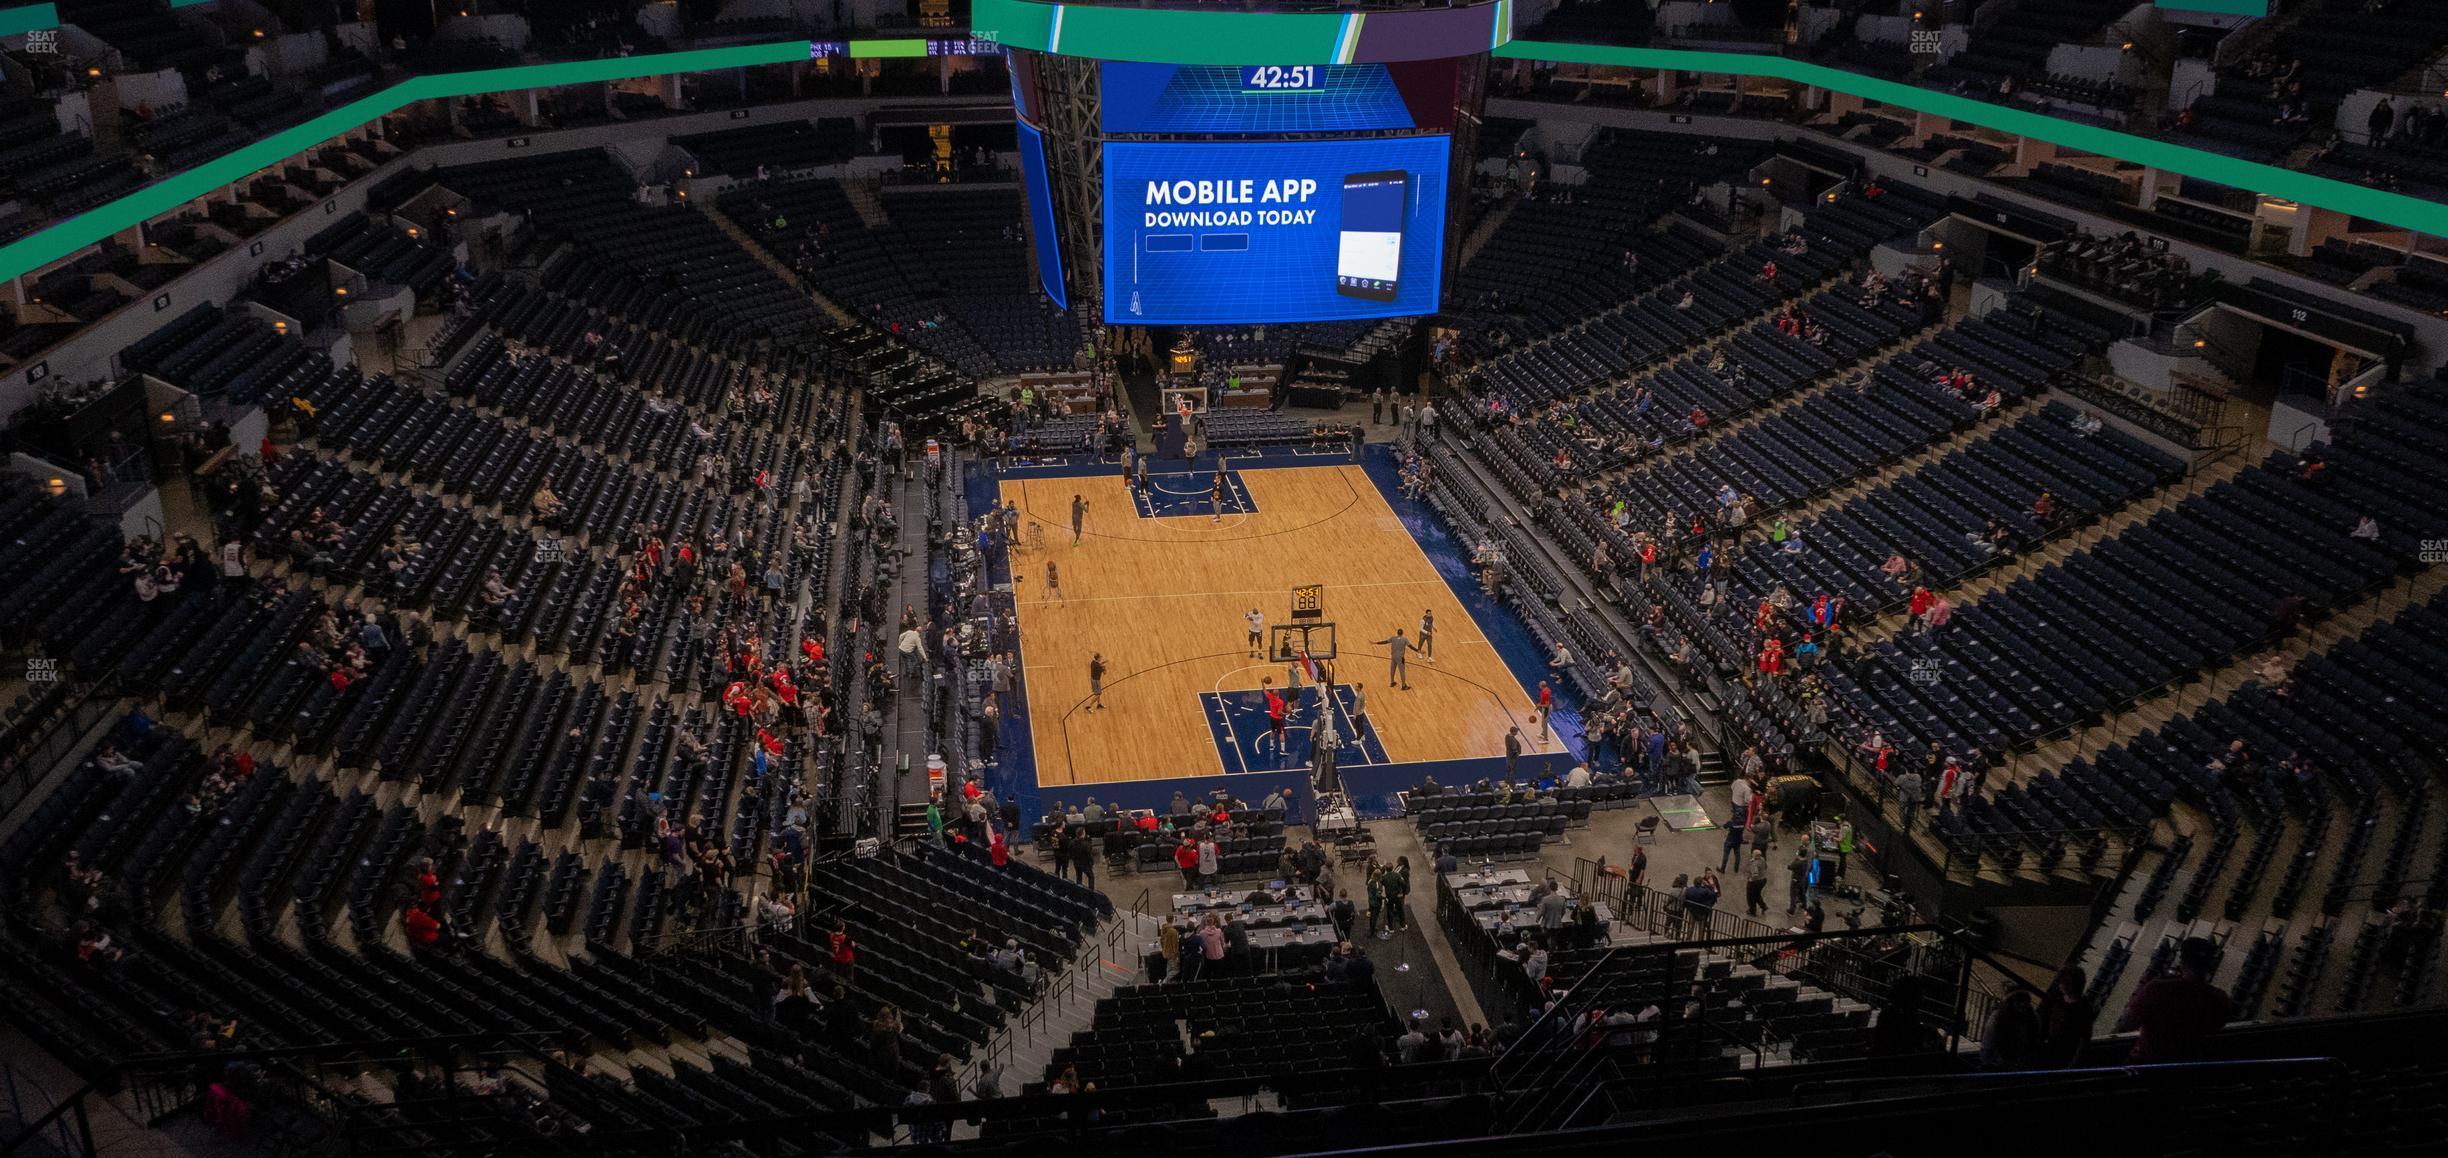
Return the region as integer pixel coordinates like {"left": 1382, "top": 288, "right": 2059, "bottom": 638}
{"left": 1826, "top": 392, "right": 2448, "bottom": 752}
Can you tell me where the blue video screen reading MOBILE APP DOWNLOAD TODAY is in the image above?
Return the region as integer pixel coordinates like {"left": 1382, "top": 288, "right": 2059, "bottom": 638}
{"left": 1104, "top": 136, "right": 1452, "bottom": 326}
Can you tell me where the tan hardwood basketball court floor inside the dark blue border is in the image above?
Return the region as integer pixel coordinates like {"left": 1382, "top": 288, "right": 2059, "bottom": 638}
{"left": 1001, "top": 465, "right": 1540, "bottom": 786}
